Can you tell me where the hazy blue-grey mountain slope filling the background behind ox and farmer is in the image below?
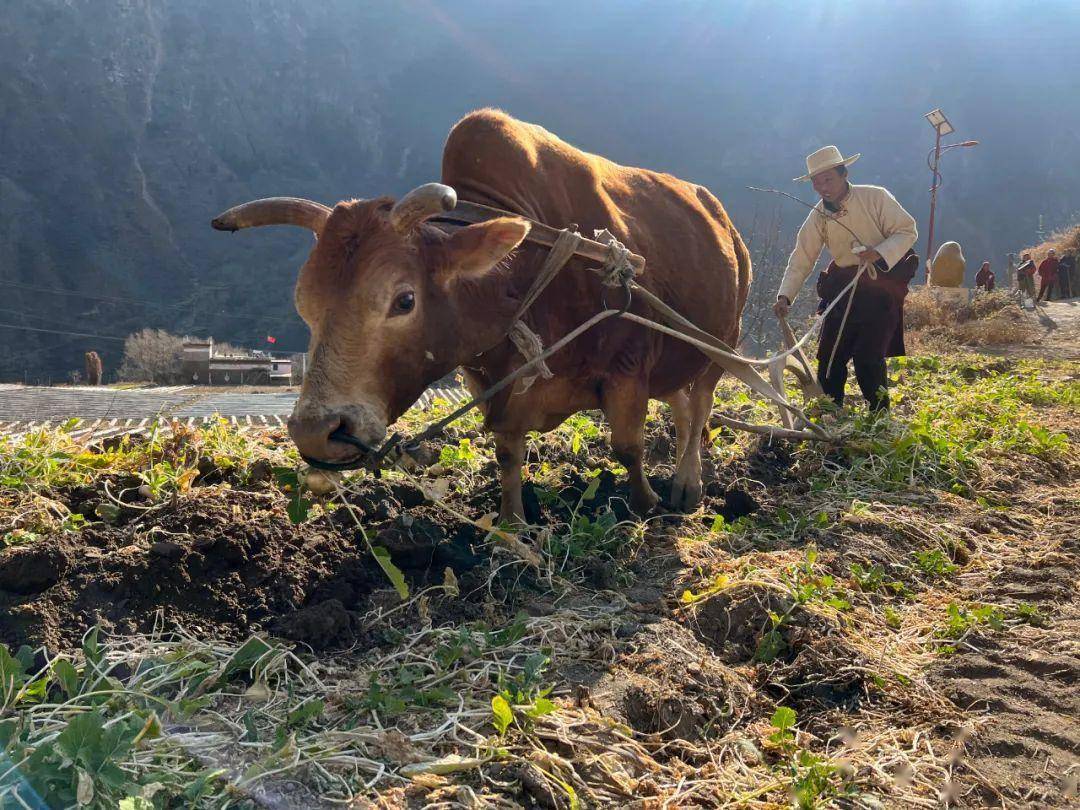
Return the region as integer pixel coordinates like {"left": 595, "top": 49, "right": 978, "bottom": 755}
{"left": 0, "top": 0, "right": 1080, "bottom": 379}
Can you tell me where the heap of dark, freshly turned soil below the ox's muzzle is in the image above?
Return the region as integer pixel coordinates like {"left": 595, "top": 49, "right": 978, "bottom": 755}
{"left": 0, "top": 482, "right": 480, "bottom": 650}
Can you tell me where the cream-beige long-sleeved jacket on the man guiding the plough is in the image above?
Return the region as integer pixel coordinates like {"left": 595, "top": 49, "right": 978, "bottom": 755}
{"left": 777, "top": 185, "right": 919, "bottom": 301}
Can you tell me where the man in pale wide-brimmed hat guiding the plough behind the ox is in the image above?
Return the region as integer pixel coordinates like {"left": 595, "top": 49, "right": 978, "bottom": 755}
{"left": 773, "top": 146, "right": 919, "bottom": 410}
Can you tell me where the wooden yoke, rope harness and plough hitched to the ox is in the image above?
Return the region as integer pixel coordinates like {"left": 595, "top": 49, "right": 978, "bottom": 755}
{"left": 302, "top": 201, "right": 846, "bottom": 475}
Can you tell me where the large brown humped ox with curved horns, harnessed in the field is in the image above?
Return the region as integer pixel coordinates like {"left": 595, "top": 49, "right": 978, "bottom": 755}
{"left": 214, "top": 110, "right": 751, "bottom": 519}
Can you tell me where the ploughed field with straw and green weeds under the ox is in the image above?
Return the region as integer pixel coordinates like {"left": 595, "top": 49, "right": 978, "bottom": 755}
{"left": 0, "top": 356, "right": 1080, "bottom": 808}
